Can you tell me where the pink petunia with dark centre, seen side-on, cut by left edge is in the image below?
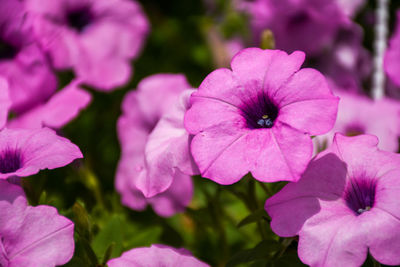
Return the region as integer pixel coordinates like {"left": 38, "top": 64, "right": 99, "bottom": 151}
{"left": 0, "top": 128, "right": 83, "bottom": 179}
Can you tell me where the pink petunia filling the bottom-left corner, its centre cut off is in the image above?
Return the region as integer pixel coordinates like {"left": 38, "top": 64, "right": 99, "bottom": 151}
{"left": 0, "top": 181, "right": 75, "bottom": 267}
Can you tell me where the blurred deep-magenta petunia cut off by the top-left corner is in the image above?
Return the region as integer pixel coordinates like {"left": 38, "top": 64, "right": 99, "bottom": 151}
{"left": 0, "top": 0, "right": 57, "bottom": 113}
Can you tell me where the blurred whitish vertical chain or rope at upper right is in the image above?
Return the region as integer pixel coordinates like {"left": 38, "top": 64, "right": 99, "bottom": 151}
{"left": 372, "top": 0, "right": 390, "bottom": 100}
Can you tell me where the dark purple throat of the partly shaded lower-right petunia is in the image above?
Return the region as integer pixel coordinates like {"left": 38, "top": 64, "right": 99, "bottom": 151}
{"left": 344, "top": 178, "right": 377, "bottom": 215}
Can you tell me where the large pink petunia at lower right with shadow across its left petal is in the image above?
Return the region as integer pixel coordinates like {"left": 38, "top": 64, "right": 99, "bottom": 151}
{"left": 265, "top": 134, "right": 400, "bottom": 266}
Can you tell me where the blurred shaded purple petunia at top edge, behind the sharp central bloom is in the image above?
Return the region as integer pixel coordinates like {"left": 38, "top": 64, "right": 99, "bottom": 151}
{"left": 241, "top": 0, "right": 349, "bottom": 55}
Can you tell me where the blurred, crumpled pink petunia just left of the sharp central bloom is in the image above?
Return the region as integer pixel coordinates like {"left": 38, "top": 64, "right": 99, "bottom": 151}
{"left": 115, "top": 74, "right": 198, "bottom": 216}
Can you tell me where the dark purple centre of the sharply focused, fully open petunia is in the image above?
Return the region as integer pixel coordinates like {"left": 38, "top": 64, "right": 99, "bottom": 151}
{"left": 240, "top": 92, "right": 279, "bottom": 129}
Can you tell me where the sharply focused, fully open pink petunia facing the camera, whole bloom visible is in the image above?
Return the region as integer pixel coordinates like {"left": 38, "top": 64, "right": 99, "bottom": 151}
{"left": 185, "top": 48, "right": 338, "bottom": 184}
